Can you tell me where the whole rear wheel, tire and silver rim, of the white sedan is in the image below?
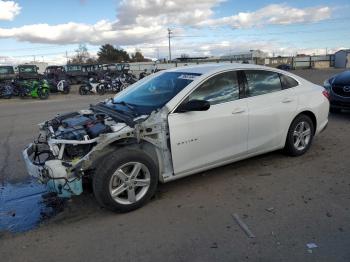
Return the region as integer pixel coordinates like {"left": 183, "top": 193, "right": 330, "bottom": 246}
{"left": 284, "top": 114, "right": 315, "bottom": 156}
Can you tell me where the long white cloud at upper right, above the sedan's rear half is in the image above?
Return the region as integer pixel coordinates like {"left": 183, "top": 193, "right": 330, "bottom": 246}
{"left": 199, "top": 4, "right": 331, "bottom": 28}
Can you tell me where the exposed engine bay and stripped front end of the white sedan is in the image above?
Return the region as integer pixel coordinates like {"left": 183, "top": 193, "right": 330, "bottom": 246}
{"left": 23, "top": 102, "right": 172, "bottom": 197}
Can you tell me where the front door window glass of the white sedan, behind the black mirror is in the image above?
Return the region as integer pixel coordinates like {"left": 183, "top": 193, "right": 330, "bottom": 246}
{"left": 189, "top": 72, "right": 239, "bottom": 105}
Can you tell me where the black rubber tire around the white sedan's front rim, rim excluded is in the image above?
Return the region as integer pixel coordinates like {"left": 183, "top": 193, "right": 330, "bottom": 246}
{"left": 92, "top": 148, "right": 159, "bottom": 213}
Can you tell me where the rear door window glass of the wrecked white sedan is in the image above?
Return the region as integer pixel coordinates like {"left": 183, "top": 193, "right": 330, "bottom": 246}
{"left": 245, "top": 70, "right": 282, "bottom": 97}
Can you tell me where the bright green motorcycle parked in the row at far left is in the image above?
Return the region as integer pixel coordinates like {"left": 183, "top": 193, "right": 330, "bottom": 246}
{"left": 14, "top": 79, "right": 50, "bottom": 99}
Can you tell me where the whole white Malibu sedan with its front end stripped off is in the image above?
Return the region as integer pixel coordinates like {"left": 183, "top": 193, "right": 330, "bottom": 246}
{"left": 23, "top": 64, "right": 329, "bottom": 212}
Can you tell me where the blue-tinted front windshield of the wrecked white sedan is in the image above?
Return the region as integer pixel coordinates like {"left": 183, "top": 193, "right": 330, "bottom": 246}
{"left": 113, "top": 72, "right": 201, "bottom": 114}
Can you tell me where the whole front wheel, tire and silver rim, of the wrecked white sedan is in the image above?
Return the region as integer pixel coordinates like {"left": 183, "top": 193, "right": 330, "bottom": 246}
{"left": 93, "top": 149, "right": 159, "bottom": 212}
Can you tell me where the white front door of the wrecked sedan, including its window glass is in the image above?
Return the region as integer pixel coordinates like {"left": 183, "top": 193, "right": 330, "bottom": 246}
{"left": 168, "top": 71, "right": 248, "bottom": 175}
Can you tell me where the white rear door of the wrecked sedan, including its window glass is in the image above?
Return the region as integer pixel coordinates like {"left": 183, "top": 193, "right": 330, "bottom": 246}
{"left": 244, "top": 70, "right": 298, "bottom": 153}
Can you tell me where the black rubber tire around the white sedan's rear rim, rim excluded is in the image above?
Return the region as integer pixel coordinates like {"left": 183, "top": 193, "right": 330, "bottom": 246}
{"left": 284, "top": 114, "right": 315, "bottom": 156}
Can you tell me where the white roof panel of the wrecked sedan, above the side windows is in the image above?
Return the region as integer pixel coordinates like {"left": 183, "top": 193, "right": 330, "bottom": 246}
{"left": 167, "top": 63, "right": 272, "bottom": 74}
